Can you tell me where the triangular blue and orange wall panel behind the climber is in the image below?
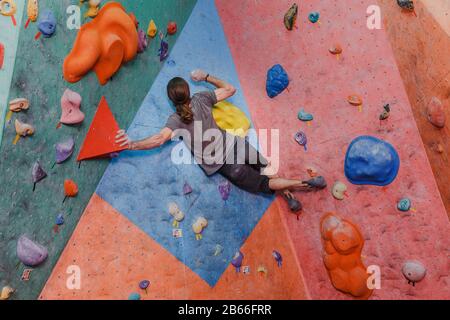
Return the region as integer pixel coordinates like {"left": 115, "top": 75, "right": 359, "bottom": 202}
{"left": 41, "top": 0, "right": 307, "bottom": 299}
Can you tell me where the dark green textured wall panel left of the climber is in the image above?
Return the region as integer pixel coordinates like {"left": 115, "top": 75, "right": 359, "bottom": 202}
{"left": 0, "top": 0, "right": 196, "bottom": 299}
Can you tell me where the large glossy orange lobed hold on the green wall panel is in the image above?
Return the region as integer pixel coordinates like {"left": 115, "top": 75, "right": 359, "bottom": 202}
{"left": 63, "top": 2, "right": 138, "bottom": 85}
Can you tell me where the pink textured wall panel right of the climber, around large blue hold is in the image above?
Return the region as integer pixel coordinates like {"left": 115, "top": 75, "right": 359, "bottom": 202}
{"left": 216, "top": 0, "right": 450, "bottom": 299}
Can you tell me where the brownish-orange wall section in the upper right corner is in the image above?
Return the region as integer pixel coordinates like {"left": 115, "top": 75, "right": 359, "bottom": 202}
{"left": 379, "top": 0, "right": 450, "bottom": 216}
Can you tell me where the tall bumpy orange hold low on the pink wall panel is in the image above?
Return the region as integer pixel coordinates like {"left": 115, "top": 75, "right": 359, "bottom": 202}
{"left": 320, "top": 213, "right": 372, "bottom": 299}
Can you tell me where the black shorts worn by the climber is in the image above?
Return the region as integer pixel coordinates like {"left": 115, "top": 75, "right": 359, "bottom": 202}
{"left": 219, "top": 141, "right": 274, "bottom": 195}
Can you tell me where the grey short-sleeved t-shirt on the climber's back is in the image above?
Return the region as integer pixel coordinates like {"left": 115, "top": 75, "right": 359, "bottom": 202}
{"left": 166, "top": 91, "right": 236, "bottom": 175}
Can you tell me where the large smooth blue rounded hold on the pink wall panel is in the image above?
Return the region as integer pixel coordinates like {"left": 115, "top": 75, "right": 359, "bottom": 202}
{"left": 345, "top": 136, "right": 400, "bottom": 186}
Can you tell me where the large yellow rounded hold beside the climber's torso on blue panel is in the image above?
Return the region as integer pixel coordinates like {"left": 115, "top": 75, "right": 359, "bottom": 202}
{"left": 213, "top": 101, "right": 251, "bottom": 138}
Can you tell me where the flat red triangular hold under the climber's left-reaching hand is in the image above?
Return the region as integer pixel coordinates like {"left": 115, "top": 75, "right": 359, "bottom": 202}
{"left": 77, "top": 97, "right": 127, "bottom": 161}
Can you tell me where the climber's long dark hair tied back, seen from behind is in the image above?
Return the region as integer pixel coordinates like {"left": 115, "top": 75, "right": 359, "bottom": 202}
{"left": 167, "top": 77, "right": 194, "bottom": 124}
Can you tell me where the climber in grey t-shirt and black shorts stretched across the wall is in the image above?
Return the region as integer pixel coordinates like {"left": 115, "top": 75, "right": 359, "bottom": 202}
{"left": 116, "top": 70, "right": 326, "bottom": 212}
